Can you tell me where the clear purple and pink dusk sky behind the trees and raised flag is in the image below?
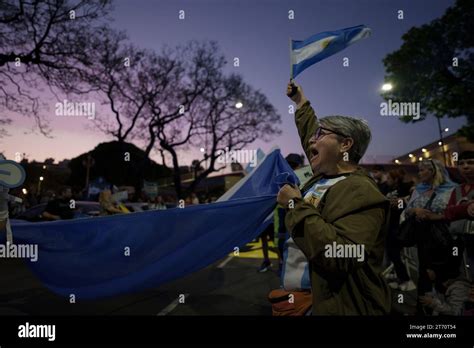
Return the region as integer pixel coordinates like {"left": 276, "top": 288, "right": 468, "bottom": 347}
{"left": 0, "top": 0, "right": 465, "bottom": 166}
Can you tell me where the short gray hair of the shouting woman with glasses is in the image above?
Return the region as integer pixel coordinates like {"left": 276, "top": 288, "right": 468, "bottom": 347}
{"left": 319, "top": 116, "right": 372, "bottom": 164}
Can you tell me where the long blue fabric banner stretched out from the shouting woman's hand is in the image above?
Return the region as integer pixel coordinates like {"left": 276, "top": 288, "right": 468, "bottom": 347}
{"left": 6, "top": 150, "right": 294, "bottom": 299}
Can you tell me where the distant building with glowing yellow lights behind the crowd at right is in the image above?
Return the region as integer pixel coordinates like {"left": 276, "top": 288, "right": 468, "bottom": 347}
{"left": 392, "top": 134, "right": 474, "bottom": 167}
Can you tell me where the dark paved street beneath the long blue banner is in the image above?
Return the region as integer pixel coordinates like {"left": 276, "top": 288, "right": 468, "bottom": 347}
{"left": 0, "top": 243, "right": 279, "bottom": 315}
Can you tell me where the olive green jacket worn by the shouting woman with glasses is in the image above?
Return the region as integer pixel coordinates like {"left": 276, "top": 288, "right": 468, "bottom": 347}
{"left": 285, "top": 102, "right": 391, "bottom": 315}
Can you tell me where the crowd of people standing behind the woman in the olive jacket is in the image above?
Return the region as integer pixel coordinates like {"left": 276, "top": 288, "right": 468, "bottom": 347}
{"left": 374, "top": 159, "right": 474, "bottom": 315}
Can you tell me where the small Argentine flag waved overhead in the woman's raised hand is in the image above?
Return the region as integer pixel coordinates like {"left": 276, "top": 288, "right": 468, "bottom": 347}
{"left": 290, "top": 25, "right": 371, "bottom": 78}
